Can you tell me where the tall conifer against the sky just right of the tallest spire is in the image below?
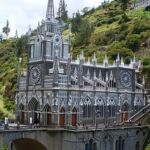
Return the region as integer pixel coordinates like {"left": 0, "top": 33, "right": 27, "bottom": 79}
{"left": 57, "top": 0, "right": 68, "bottom": 22}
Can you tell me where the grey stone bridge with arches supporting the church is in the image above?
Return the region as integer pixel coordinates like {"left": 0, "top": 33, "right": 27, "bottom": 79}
{"left": 0, "top": 126, "right": 150, "bottom": 150}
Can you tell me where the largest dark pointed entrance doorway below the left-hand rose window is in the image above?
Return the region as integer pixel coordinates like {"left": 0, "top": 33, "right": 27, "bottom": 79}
{"left": 28, "top": 98, "right": 40, "bottom": 124}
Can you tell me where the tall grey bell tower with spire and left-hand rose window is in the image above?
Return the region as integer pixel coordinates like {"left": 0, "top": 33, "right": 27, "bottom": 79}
{"left": 27, "top": 0, "right": 69, "bottom": 86}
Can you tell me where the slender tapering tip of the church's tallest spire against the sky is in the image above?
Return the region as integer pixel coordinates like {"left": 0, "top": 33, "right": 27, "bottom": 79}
{"left": 46, "top": 0, "right": 54, "bottom": 20}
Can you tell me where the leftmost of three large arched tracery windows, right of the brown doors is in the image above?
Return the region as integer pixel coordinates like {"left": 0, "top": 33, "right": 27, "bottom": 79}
{"left": 83, "top": 98, "right": 92, "bottom": 118}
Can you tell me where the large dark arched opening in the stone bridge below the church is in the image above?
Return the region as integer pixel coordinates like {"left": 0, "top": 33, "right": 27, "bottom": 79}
{"left": 11, "top": 138, "right": 47, "bottom": 150}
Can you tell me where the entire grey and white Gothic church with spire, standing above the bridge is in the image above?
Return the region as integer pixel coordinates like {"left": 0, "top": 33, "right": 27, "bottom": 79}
{"left": 16, "top": 0, "right": 145, "bottom": 127}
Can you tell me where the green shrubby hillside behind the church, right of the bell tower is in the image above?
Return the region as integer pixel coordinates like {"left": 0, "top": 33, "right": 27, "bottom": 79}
{"left": 69, "top": 1, "right": 150, "bottom": 89}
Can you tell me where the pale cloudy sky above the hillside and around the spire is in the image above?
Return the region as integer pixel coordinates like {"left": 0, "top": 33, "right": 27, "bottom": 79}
{"left": 0, "top": 0, "right": 103, "bottom": 36}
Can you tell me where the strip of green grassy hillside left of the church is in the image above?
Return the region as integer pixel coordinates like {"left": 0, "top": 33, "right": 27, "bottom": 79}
{"left": 0, "top": 39, "right": 17, "bottom": 118}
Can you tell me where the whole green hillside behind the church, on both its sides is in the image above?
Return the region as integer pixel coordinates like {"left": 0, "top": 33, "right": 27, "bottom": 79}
{"left": 0, "top": 1, "right": 150, "bottom": 118}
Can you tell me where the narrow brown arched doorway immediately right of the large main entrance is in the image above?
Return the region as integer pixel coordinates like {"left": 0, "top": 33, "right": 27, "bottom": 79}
{"left": 44, "top": 104, "right": 52, "bottom": 125}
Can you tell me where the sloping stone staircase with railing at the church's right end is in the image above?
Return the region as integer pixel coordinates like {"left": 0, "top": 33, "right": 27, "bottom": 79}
{"left": 126, "top": 104, "right": 150, "bottom": 123}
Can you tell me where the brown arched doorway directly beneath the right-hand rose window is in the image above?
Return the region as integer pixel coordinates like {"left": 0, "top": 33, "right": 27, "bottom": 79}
{"left": 121, "top": 102, "right": 129, "bottom": 122}
